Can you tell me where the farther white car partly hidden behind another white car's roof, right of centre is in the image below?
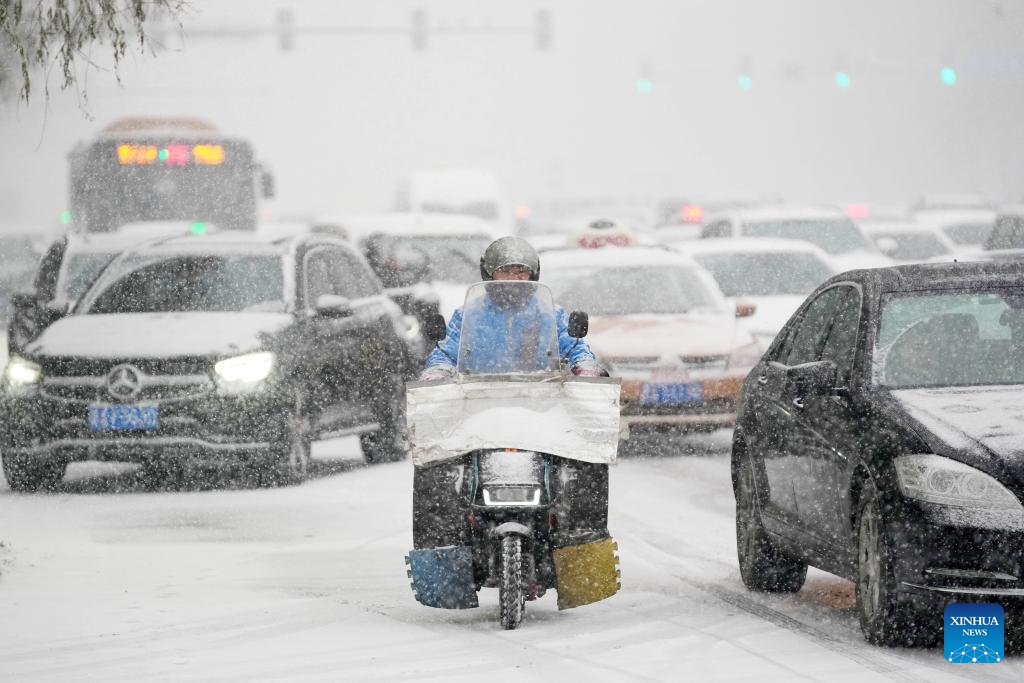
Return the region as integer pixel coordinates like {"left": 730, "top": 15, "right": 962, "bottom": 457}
{"left": 700, "top": 205, "right": 892, "bottom": 270}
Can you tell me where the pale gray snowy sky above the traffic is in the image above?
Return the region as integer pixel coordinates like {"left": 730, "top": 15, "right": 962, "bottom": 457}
{"left": 0, "top": 0, "right": 1024, "bottom": 229}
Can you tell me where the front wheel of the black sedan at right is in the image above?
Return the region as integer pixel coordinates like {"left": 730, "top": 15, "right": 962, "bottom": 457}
{"left": 857, "top": 480, "right": 941, "bottom": 646}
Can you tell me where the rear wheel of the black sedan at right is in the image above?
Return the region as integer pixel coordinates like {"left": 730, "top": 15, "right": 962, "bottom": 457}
{"left": 735, "top": 457, "right": 807, "bottom": 593}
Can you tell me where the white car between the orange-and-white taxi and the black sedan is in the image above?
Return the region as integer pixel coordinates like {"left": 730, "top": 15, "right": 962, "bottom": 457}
{"left": 670, "top": 238, "right": 838, "bottom": 349}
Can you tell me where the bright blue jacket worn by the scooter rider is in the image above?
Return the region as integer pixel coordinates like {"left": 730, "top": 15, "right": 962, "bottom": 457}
{"left": 426, "top": 302, "right": 597, "bottom": 373}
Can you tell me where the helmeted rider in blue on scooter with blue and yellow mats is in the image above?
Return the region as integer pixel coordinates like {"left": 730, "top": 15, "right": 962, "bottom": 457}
{"left": 407, "top": 238, "right": 618, "bottom": 629}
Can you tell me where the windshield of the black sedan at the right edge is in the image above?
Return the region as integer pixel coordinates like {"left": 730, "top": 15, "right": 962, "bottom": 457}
{"left": 872, "top": 287, "right": 1024, "bottom": 387}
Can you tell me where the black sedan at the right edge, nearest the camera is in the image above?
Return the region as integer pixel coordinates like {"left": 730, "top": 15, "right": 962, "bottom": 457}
{"left": 732, "top": 262, "right": 1024, "bottom": 644}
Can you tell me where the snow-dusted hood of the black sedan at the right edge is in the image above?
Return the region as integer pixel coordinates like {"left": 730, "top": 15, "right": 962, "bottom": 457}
{"left": 892, "top": 386, "right": 1024, "bottom": 476}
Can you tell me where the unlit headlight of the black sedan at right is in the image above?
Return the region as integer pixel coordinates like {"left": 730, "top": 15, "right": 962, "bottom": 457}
{"left": 894, "top": 454, "right": 1024, "bottom": 528}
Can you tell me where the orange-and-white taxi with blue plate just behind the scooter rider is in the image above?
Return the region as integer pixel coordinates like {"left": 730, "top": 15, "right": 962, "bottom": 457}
{"left": 541, "top": 247, "right": 761, "bottom": 430}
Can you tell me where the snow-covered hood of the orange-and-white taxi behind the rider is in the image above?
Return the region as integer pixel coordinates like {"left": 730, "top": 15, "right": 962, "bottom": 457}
{"left": 587, "top": 313, "right": 754, "bottom": 357}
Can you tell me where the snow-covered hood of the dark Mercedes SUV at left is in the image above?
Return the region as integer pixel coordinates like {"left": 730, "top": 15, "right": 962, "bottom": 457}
{"left": 26, "top": 312, "right": 292, "bottom": 358}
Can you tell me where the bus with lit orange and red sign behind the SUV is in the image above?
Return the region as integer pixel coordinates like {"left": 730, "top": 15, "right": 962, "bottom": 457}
{"left": 65, "top": 117, "right": 273, "bottom": 232}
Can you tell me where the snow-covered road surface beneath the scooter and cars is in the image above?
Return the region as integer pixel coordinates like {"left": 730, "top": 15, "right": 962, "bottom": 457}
{"left": 0, "top": 432, "right": 1024, "bottom": 683}
